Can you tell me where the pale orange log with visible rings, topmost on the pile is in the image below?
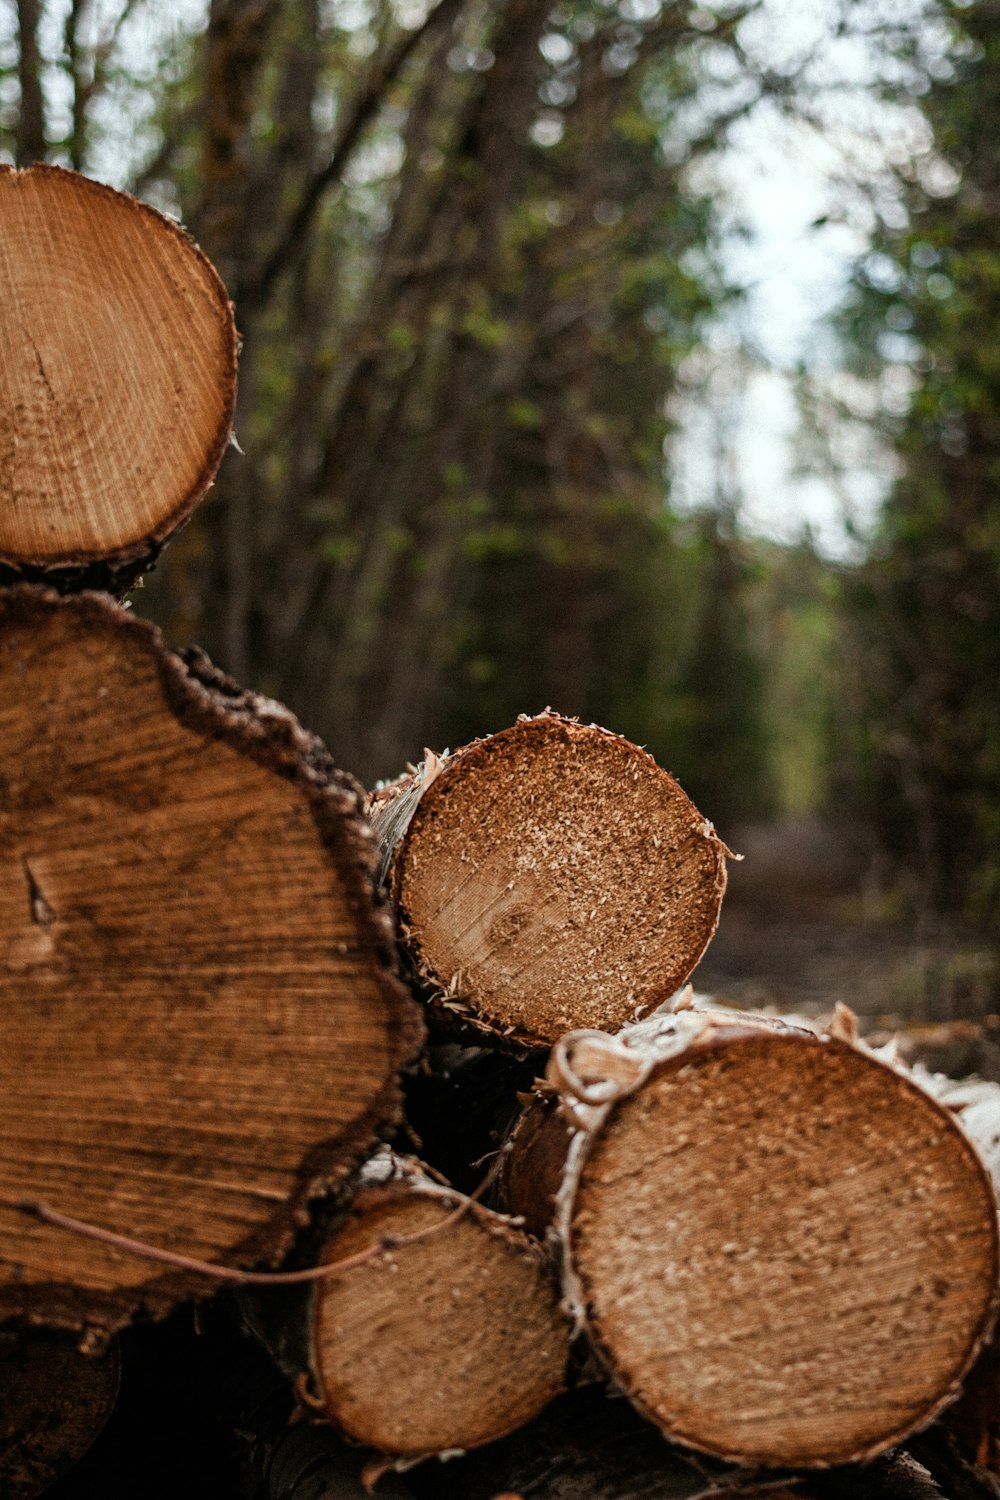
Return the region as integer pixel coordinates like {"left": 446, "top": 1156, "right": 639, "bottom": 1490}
{"left": 0, "top": 165, "right": 237, "bottom": 591}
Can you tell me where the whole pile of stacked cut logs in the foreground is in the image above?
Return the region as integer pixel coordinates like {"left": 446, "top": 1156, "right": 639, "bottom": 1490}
{"left": 0, "top": 168, "right": 1000, "bottom": 1500}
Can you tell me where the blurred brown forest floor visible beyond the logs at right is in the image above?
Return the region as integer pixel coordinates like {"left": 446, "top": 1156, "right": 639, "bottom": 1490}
{"left": 693, "top": 821, "right": 1000, "bottom": 1079}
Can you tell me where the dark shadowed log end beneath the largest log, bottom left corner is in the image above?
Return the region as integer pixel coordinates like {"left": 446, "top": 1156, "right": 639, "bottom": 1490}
{"left": 0, "top": 1328, "right": 120, "bottom": 1500}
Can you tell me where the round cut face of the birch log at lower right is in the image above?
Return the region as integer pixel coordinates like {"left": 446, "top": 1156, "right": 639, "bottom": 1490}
{"left": 568, "top": 1034, "right": 997, "bottom": 1467}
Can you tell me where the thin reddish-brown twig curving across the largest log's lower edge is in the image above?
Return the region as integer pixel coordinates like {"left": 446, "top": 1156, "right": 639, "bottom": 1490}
{"left": 0, "top": 1152, "right": 504, "bottom": 1287}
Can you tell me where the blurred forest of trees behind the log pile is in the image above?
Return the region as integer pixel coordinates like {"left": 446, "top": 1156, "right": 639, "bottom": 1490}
{"left": 0, "top": 0, "right": 1000, "bottom": 1017}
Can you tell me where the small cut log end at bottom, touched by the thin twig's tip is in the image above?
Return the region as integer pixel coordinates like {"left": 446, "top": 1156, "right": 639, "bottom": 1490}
{"left": 312, "top": 1187, "right": 568, "bottom": 1457}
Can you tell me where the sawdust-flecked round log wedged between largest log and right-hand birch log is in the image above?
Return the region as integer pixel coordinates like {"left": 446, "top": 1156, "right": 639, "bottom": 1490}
{"left": 372, "top": 713, "right": 727, "bottom": 1047}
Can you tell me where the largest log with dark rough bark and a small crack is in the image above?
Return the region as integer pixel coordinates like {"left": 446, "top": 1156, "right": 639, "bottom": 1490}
{"left": 0, "top": 585, "right": 421, "bottom": 1331}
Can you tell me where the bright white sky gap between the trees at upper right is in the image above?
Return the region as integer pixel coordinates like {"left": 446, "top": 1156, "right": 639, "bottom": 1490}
{"left": 672, "top": 0, "right": 955, "bottom": 557}
